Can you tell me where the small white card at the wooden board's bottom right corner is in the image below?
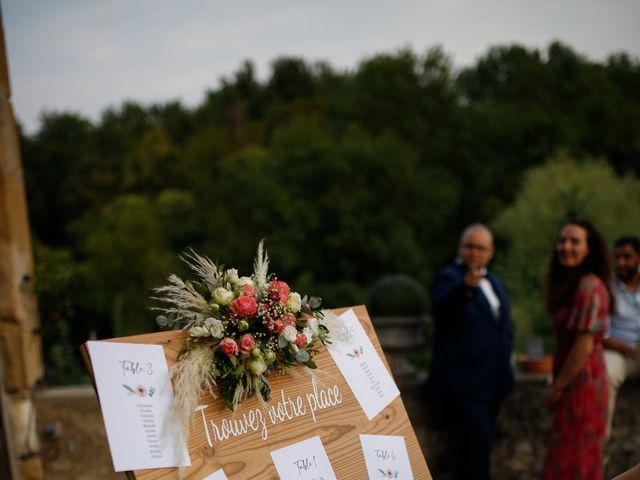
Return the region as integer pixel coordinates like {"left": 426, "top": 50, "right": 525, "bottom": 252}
{"left": 360, "top": 435, "right": 413, "bottom": 480}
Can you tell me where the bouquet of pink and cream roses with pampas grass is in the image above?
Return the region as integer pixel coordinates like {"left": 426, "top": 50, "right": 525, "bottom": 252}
{"left": 154, "top": 242, "right": 340, "bottom": 452}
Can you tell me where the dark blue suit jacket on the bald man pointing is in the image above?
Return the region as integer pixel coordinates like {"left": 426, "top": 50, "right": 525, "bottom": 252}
{"left": 429, "top": 264, "right": 513, "bottom": 400}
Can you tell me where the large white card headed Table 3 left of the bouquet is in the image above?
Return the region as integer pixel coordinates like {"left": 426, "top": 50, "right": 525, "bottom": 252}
{"left": 87, "top": 342, "right": 191, "bottom": 472}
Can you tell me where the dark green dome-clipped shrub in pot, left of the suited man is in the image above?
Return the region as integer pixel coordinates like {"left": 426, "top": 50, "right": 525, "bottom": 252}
{"left": 367, "top": 274, "right": 427, "bottom": 316}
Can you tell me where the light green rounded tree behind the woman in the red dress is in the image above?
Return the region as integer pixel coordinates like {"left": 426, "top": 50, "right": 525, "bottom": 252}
{"left": 492, "top": 152, "right": 640, "bottom": 348}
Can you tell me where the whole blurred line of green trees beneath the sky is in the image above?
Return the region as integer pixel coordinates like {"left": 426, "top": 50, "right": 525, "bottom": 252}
{"left": 21, "top": 42, "right": 640, "bottom": 382}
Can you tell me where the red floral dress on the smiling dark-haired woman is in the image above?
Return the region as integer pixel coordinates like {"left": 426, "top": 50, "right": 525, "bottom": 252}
{"left": 544, "top": 274, "right": 609, "bottom": 480}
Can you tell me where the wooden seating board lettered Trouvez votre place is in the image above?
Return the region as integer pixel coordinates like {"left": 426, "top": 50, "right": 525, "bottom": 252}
{"left": 84, "top": 306, "right": 431, "bottom": 480}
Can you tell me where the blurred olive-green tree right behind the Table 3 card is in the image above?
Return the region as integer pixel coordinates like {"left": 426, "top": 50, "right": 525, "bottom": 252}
{"left": 76, "top": 195, "right": 175, "bottom": 336}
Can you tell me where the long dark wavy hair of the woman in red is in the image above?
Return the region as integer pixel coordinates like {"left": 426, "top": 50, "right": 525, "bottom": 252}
{"left": 544, "top": 220, "right": 613, "bottom": 314}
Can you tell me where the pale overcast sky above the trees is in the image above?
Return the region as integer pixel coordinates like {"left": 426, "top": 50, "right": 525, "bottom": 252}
{"left": 0, "top": 0, "right": 640, "bottom": 133}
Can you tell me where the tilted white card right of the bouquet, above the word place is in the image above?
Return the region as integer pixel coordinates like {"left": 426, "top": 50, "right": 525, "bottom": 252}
{"left": 328, "top": 310, "right": 400, "bottom": 420}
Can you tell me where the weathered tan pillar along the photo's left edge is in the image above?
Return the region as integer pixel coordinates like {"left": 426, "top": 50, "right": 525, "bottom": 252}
{"left": 0, "top": 7, "right": 44, "bottom": 480}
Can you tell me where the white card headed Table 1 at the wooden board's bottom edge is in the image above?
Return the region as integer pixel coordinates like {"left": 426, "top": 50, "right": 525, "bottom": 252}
{"left": 271, "top": 435, "right": 336, "bottom": 480}
